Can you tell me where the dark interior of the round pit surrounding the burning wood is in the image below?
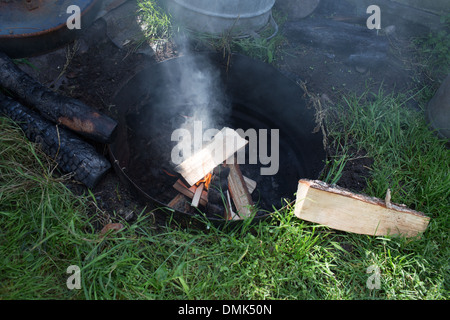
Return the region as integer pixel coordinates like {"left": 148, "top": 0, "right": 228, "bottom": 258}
{"left": 110, "top": 54, "right": 325, "bottom": 220}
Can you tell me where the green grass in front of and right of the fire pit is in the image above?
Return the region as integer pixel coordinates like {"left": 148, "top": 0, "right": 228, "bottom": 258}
{"left": 0, "top": 89, "right": 450, "bottom": 300}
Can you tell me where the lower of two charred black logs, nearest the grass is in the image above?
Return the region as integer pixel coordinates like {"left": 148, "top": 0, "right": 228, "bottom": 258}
{"left": 0, "top": 93, "right": 111, "bottom": 188}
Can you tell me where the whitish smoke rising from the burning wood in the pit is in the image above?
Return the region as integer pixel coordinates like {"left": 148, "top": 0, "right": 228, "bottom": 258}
{"left": 152, "top": 37, "right": 231, "bottom": 165}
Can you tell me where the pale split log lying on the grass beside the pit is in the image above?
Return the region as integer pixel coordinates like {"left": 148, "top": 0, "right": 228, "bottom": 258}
{"left": 294, "top": 179, "right": 430, "bottom": 237}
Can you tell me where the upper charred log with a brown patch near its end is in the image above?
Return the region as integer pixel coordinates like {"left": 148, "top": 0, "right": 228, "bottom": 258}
{"left": 0, "top": 52, "right": 117, "bottom": 143}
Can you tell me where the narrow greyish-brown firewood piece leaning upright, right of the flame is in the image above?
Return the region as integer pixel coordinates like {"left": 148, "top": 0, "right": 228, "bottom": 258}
{"left": 228, "top": 164, "right": 253, "bottom": 218}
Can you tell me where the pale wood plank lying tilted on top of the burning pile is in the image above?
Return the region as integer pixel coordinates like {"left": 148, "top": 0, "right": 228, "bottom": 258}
{"left": 175, "top": 127, "right": 248, "bottom": 186}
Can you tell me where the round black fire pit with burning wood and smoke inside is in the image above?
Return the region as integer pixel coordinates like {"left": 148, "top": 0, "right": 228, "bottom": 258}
{"left": 109, "top": 54, "right": 325, "bottom": 223}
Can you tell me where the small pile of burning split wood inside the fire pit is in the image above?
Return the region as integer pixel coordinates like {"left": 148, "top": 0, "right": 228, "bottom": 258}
{"left": 172, "top": 128, "right": 256, "bottom": 219}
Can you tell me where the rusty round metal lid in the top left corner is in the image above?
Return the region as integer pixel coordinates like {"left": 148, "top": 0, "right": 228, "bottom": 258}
{"left": 0, "top": 0, "right": 101, "bottom": 58}
